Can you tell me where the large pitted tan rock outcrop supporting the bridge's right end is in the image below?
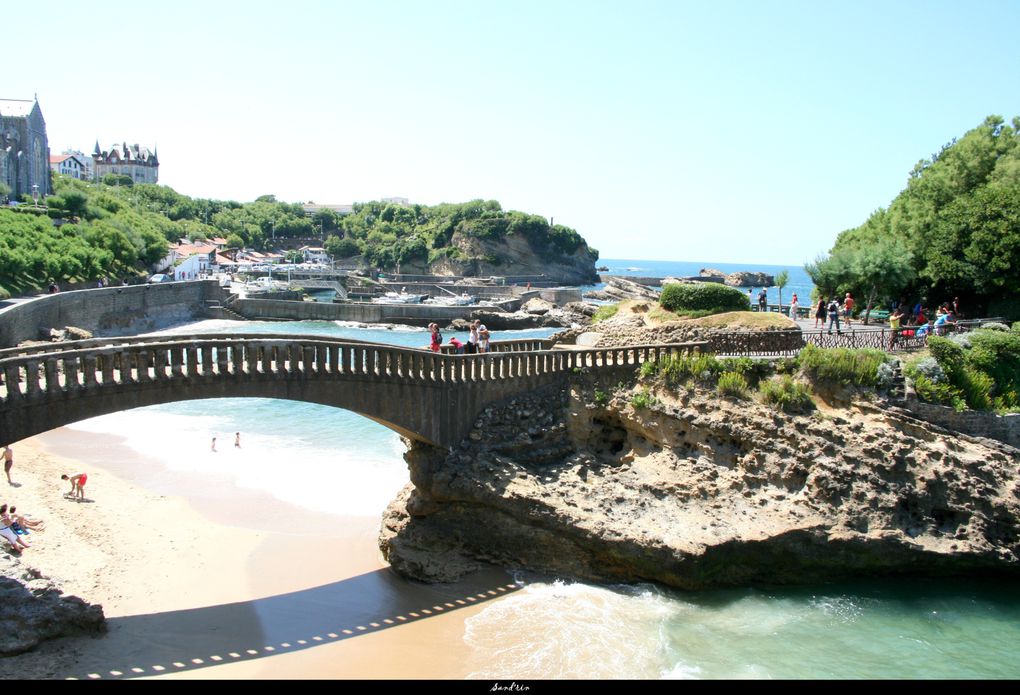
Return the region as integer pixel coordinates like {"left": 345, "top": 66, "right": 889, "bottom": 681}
{"left": 380, "top": 376, "right": 1020, "bottom": 589}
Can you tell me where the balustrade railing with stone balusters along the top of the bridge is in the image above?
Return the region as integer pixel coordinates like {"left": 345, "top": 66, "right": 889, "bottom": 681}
{"left": 0, "top": 335, "right": 705, "bottom": 406}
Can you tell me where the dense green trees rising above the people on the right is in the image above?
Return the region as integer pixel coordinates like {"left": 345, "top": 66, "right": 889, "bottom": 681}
{"left": 807, "top": 115, "right": 1020, "bottom": 318}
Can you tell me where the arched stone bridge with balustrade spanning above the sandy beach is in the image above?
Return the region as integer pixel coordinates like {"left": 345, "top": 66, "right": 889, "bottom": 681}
{"left": 0, "top": 334, "right": 705, "bottom": 447}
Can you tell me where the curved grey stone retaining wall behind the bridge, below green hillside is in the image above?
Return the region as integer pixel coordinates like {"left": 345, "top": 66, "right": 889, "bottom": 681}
{"left": 0, "top": 280, "right": 225, "bottom": 347}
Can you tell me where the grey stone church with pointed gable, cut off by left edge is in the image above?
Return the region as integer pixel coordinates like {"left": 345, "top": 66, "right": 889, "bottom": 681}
{"left": 0, "top": 94, "right": 53, "bottom": 200}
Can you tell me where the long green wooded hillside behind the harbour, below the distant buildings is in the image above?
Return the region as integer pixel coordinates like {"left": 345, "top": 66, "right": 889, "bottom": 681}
{"left": 0, "top": 176, "right": 598, "bottom": 296}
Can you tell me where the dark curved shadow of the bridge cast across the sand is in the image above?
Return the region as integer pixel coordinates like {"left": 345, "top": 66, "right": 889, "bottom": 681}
{"left": 55, "top": 569, "right": 519, "bottom": 681}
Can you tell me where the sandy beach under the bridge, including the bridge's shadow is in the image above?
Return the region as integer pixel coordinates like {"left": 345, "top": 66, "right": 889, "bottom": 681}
{"left": 0, "top": 429, "right": 516, "bottom": 680}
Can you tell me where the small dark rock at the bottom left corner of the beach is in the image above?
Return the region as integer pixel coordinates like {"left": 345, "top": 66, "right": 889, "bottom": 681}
{"left": 0, "top": 559, "right": 106, "bottom": 656}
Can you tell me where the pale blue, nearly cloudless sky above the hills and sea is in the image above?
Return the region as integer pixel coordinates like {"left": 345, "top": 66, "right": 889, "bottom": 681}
{"left": 7, "top": 0, "right": 1020, "bottom": 264}
